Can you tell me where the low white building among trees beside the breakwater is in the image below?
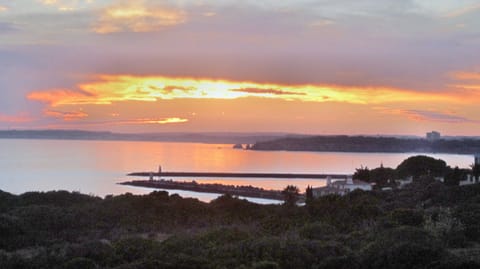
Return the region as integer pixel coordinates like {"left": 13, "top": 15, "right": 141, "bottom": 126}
{"left": 312, "top": 176, "right": 372, "bottom": 197}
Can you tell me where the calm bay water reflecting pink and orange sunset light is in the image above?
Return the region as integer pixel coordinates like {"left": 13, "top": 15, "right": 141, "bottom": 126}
{"left": 0, "top": 139, "right": 473, "bottom": 201}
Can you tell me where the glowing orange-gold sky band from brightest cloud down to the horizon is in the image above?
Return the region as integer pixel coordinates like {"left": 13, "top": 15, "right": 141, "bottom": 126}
{"left": 27, "top": 75, "right": 480, "bottom": 132}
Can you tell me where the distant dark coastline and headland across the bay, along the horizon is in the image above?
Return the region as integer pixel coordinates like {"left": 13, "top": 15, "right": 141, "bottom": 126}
{"left": 0, "top": 130, "right": 480, "bottom": 154}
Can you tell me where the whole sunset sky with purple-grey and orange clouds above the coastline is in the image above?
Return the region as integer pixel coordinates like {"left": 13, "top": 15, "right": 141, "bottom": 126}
{"left": 0, "top": 0, "right": 480, "bottom": 136}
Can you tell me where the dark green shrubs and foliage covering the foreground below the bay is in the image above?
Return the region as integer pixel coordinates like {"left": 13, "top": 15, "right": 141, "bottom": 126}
{"left": 0, "top": 181, "right": 480, "bottom": 268}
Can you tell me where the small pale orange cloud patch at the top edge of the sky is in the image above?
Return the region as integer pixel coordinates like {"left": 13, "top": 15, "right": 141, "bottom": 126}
{"left": 93, "top": 0, "right": 186, "bottom": 34}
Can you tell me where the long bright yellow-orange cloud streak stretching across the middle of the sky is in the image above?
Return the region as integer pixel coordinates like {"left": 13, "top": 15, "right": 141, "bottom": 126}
{"left": 28, "top": 75, "right": 468, "bottom": 106}
